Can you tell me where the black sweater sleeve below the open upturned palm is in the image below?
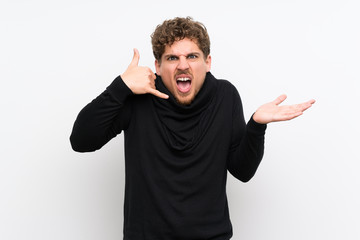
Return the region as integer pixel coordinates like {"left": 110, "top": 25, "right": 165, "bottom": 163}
{"left": 228, "top": 91, "right": 267, "bottom": 182}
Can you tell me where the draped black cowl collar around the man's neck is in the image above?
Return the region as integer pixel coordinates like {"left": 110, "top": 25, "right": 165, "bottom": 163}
{"left": 152, "top": 72, "right": 217, "bottom": 154}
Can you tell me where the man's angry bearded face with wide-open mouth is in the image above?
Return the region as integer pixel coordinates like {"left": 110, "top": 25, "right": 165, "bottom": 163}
{"left": 155, "top": 38, "right": 211, "bottom": 105}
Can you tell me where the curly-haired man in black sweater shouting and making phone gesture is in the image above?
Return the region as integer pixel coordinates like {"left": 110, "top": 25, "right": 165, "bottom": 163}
{"left": 70, "top": 18, "right": 315, "bottom": 240}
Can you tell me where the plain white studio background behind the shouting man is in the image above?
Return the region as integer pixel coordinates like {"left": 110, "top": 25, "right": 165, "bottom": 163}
{"left": 0, "top": 0, "right": 360, "bottom": 240}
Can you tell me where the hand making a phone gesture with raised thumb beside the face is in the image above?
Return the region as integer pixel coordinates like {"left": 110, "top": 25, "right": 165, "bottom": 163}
{"left": 121, "top": 48, "right": 169, "bottom": 99}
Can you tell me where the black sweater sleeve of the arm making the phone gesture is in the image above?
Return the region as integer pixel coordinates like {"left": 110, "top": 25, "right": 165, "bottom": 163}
{"left": 70, "top": 76, "right": 133, "bottom": 152}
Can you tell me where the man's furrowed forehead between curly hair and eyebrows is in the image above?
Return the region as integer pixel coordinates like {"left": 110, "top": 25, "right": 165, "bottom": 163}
{"left": 163, "top": 38, "right": 202, "bottom": 55}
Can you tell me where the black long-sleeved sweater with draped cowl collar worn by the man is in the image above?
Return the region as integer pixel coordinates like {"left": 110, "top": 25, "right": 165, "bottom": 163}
{"left": 70, "top": 73, "right": 266, "bottom": 240}
